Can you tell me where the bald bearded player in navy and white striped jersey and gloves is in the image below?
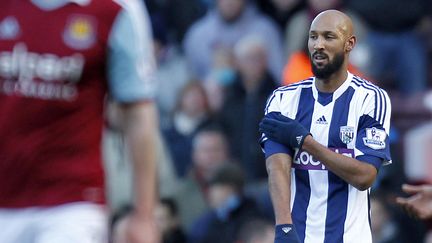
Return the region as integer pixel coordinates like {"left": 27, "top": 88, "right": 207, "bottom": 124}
{"left": 260, "top": 10, "right": 391, "bottom": 243}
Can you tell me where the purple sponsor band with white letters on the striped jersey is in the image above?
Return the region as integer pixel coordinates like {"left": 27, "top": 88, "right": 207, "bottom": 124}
{"left": 292, "top": 148, "right": 354, "bottom": 170}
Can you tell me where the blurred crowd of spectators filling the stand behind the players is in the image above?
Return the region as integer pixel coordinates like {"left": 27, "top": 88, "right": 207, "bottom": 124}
{"left": 103, "top": 0, "right": 432, "bottom": 243}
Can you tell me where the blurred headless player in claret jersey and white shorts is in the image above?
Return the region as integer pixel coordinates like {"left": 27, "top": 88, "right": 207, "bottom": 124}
{"left": 0, "top": 0, "right": 159, "bottom": 243}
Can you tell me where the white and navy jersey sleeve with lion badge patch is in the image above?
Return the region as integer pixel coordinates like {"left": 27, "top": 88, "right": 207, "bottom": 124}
{"left": 355, "top": 89, "right": 391, "bottom": 169}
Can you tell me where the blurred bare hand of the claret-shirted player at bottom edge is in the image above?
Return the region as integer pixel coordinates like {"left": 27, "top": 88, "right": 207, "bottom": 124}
{"left": 113, "top": 212, "right": 160, "bottom": 243}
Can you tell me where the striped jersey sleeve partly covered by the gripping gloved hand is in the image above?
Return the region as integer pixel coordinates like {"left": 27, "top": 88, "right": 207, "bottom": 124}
{"left": 260, "top": 90, "right": 294, "bottom": 158}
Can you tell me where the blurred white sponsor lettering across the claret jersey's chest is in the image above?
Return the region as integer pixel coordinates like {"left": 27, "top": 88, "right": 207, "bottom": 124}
{"left": 0, "top": 43, "right": 85, "bottom": 100}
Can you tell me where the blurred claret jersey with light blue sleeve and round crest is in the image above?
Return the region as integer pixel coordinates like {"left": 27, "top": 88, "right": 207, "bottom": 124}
{"left": 0, "top": 0, "right": 154, "bottom": 207}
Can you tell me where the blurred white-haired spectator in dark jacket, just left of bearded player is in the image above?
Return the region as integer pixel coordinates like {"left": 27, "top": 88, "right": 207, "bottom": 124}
{"left": 219, "top": 35, "right": 276, "bottom": 181}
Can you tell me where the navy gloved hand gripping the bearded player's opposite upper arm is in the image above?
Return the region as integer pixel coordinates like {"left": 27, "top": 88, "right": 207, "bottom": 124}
{"left": 259, "top": 112, "right": 310, "bottom": 149}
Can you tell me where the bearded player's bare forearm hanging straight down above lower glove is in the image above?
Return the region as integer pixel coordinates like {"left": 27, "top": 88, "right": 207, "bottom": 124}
{"left": 267, "top": 154, "right": 292, "bottom": 224}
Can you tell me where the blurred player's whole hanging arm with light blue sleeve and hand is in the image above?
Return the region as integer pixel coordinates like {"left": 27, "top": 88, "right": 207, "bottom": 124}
{"left": 107, "top": 0, "right": 159, "bottom": 243}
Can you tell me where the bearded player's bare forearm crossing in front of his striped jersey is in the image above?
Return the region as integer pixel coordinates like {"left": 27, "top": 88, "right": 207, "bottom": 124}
{"left": 302, "top": 136, "right": 377, "bottom": 190}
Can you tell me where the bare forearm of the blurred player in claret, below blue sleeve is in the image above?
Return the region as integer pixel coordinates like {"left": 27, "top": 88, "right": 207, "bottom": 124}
{"left": 125, "top": 103, "right": 158, "bottom": 217}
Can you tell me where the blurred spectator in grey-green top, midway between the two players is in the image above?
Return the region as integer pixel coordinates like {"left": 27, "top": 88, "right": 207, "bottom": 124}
{"left": 174, "top": 125, "right": 231, "bottom": 229}
